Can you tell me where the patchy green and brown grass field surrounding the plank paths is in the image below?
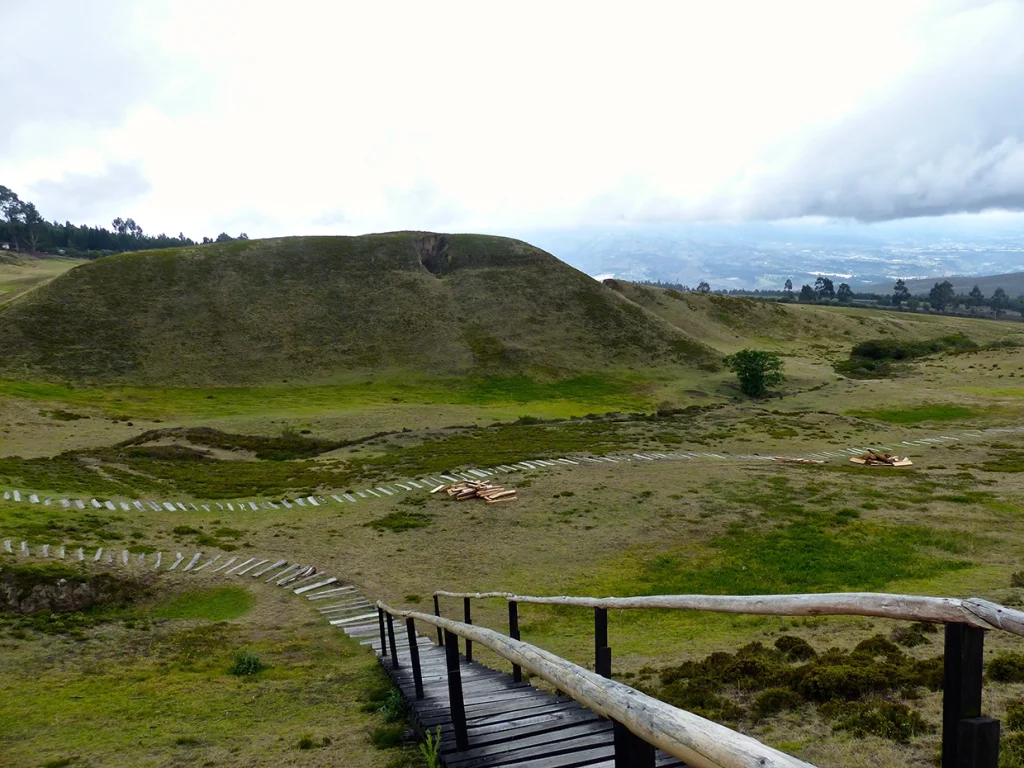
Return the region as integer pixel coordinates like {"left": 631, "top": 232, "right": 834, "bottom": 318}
{"left": 6, "top": 296, "right": 1024, "bottom": 768}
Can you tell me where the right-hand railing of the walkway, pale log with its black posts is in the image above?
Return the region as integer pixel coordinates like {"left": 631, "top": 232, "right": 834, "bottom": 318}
{"left": 434, "top": 590, "right": 1024, "bottom": 768}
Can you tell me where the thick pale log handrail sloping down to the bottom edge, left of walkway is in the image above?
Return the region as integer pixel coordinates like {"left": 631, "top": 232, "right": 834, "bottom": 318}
{"left": 377, "top": 593, "right": 813, "bottom": 768}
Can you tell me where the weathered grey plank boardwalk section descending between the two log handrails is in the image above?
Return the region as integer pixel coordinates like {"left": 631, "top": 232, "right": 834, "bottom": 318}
{"left": 332, "top": 595, "right": 685, "bottom": 768}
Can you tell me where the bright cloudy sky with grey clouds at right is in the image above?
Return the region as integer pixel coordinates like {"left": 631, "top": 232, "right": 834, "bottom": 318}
{"left": 0, "top": 0, "right": 1024, "bottom": 237}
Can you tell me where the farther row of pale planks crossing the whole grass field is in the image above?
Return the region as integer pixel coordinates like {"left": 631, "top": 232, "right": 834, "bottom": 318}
{"left": 3, "top": 425, "right": 1024, "bottom": 512}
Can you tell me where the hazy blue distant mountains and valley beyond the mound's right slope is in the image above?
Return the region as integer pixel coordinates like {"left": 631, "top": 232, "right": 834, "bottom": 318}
{"left": 516, "top": 222, "right": 1024, "bottom": 295}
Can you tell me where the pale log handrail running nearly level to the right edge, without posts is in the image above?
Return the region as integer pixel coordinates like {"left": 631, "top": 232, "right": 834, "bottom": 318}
{"left": 434, "top": 590, "right": 1024, "bottom": 637}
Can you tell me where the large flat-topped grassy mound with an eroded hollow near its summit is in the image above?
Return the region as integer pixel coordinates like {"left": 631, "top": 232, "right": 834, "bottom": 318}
{"left": 0, "top": 232, "right": 718, "bottom": 385}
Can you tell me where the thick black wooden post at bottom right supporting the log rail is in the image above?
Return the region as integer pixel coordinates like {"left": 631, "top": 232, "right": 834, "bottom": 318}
{"left": 942, "top": 623, "right": 999, "bottom": 768}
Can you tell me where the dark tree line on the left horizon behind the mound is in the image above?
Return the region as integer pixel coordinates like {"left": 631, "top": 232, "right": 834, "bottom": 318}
{"left": 0, "top": 184, "right": 249, "bottom": 258}
